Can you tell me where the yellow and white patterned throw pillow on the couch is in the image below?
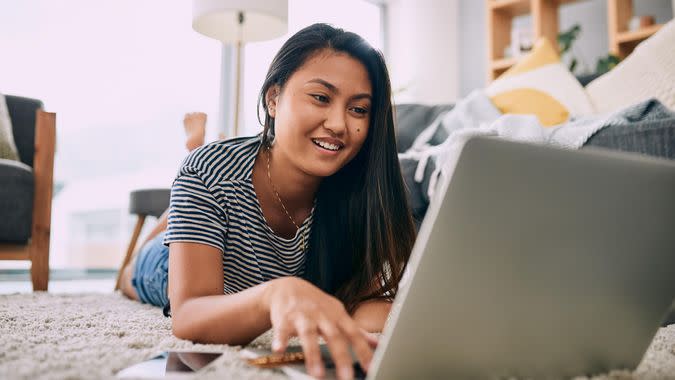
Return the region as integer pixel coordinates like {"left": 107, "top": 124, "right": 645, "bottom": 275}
{"left": 485, "top": 37, "right": 593, "bottom": 127}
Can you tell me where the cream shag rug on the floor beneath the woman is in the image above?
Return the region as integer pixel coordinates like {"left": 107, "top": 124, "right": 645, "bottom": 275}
{"left": 0, "top": 292, "right": 675, "bottom": 380}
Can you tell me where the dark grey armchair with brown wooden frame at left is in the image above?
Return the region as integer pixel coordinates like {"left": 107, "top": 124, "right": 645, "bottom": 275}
{"left": 0, "top": 96, "right": 56, "bottom": 291}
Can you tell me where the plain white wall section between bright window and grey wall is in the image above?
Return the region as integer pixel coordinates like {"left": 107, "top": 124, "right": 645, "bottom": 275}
{"left": 386, "top": 0, "right": 459, "bottom": 104}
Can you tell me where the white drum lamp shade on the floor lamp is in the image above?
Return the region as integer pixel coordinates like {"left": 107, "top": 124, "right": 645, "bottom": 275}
{"left": 192, "top": 0, "right": 288, "bottom": 43}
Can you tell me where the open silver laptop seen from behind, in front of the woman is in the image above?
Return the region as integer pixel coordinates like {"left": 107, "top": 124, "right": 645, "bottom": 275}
{"left": 368, "top": 137, "right": 675, "bottom": 379}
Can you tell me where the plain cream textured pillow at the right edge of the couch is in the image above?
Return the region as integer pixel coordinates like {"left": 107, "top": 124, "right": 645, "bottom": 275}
{"left": 586, "top": 20, "right": 675, "bottom": 113}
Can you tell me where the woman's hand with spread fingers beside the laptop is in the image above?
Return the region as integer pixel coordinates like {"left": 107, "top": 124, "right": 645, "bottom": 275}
{"left": 263, "top": 277, "right": 377, "bottom": 379}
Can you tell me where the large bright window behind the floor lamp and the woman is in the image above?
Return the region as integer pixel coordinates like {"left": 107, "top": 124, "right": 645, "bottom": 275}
{"left": 0, "top": 0, "right": 382, "bottom": 269}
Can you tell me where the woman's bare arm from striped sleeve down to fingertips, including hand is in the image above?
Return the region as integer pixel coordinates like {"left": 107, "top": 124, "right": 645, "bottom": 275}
{"left": 169, "top": 243, "right": 376, "bottom": 378}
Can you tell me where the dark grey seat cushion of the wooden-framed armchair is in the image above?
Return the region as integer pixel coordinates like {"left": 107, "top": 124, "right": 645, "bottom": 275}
{"left": 0, "top": 159, "right": 34, "bottom": 244}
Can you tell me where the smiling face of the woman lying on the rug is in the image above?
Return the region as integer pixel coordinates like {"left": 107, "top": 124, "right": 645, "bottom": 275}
{"left": 268, "top": 50, "right": 372, "bottom": 177}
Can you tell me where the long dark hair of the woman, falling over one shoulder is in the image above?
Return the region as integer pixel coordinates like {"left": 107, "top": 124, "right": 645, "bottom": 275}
{"left": 258, "top": 24, "right": 415, "bottom": 313}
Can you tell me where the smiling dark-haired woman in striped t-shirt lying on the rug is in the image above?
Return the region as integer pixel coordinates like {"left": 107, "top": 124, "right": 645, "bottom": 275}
{"left": 125, "top": 24, "right": 415, "bottom": 378}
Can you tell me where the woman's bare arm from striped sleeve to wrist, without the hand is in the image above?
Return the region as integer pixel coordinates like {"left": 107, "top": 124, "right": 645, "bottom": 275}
{"left": 169, "top": 243, "right": 271, "bottom": 345}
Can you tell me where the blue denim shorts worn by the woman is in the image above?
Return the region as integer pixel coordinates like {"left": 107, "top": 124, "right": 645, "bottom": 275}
{"left": 131, "top": 232, "right": 169, "bottom": 307}
